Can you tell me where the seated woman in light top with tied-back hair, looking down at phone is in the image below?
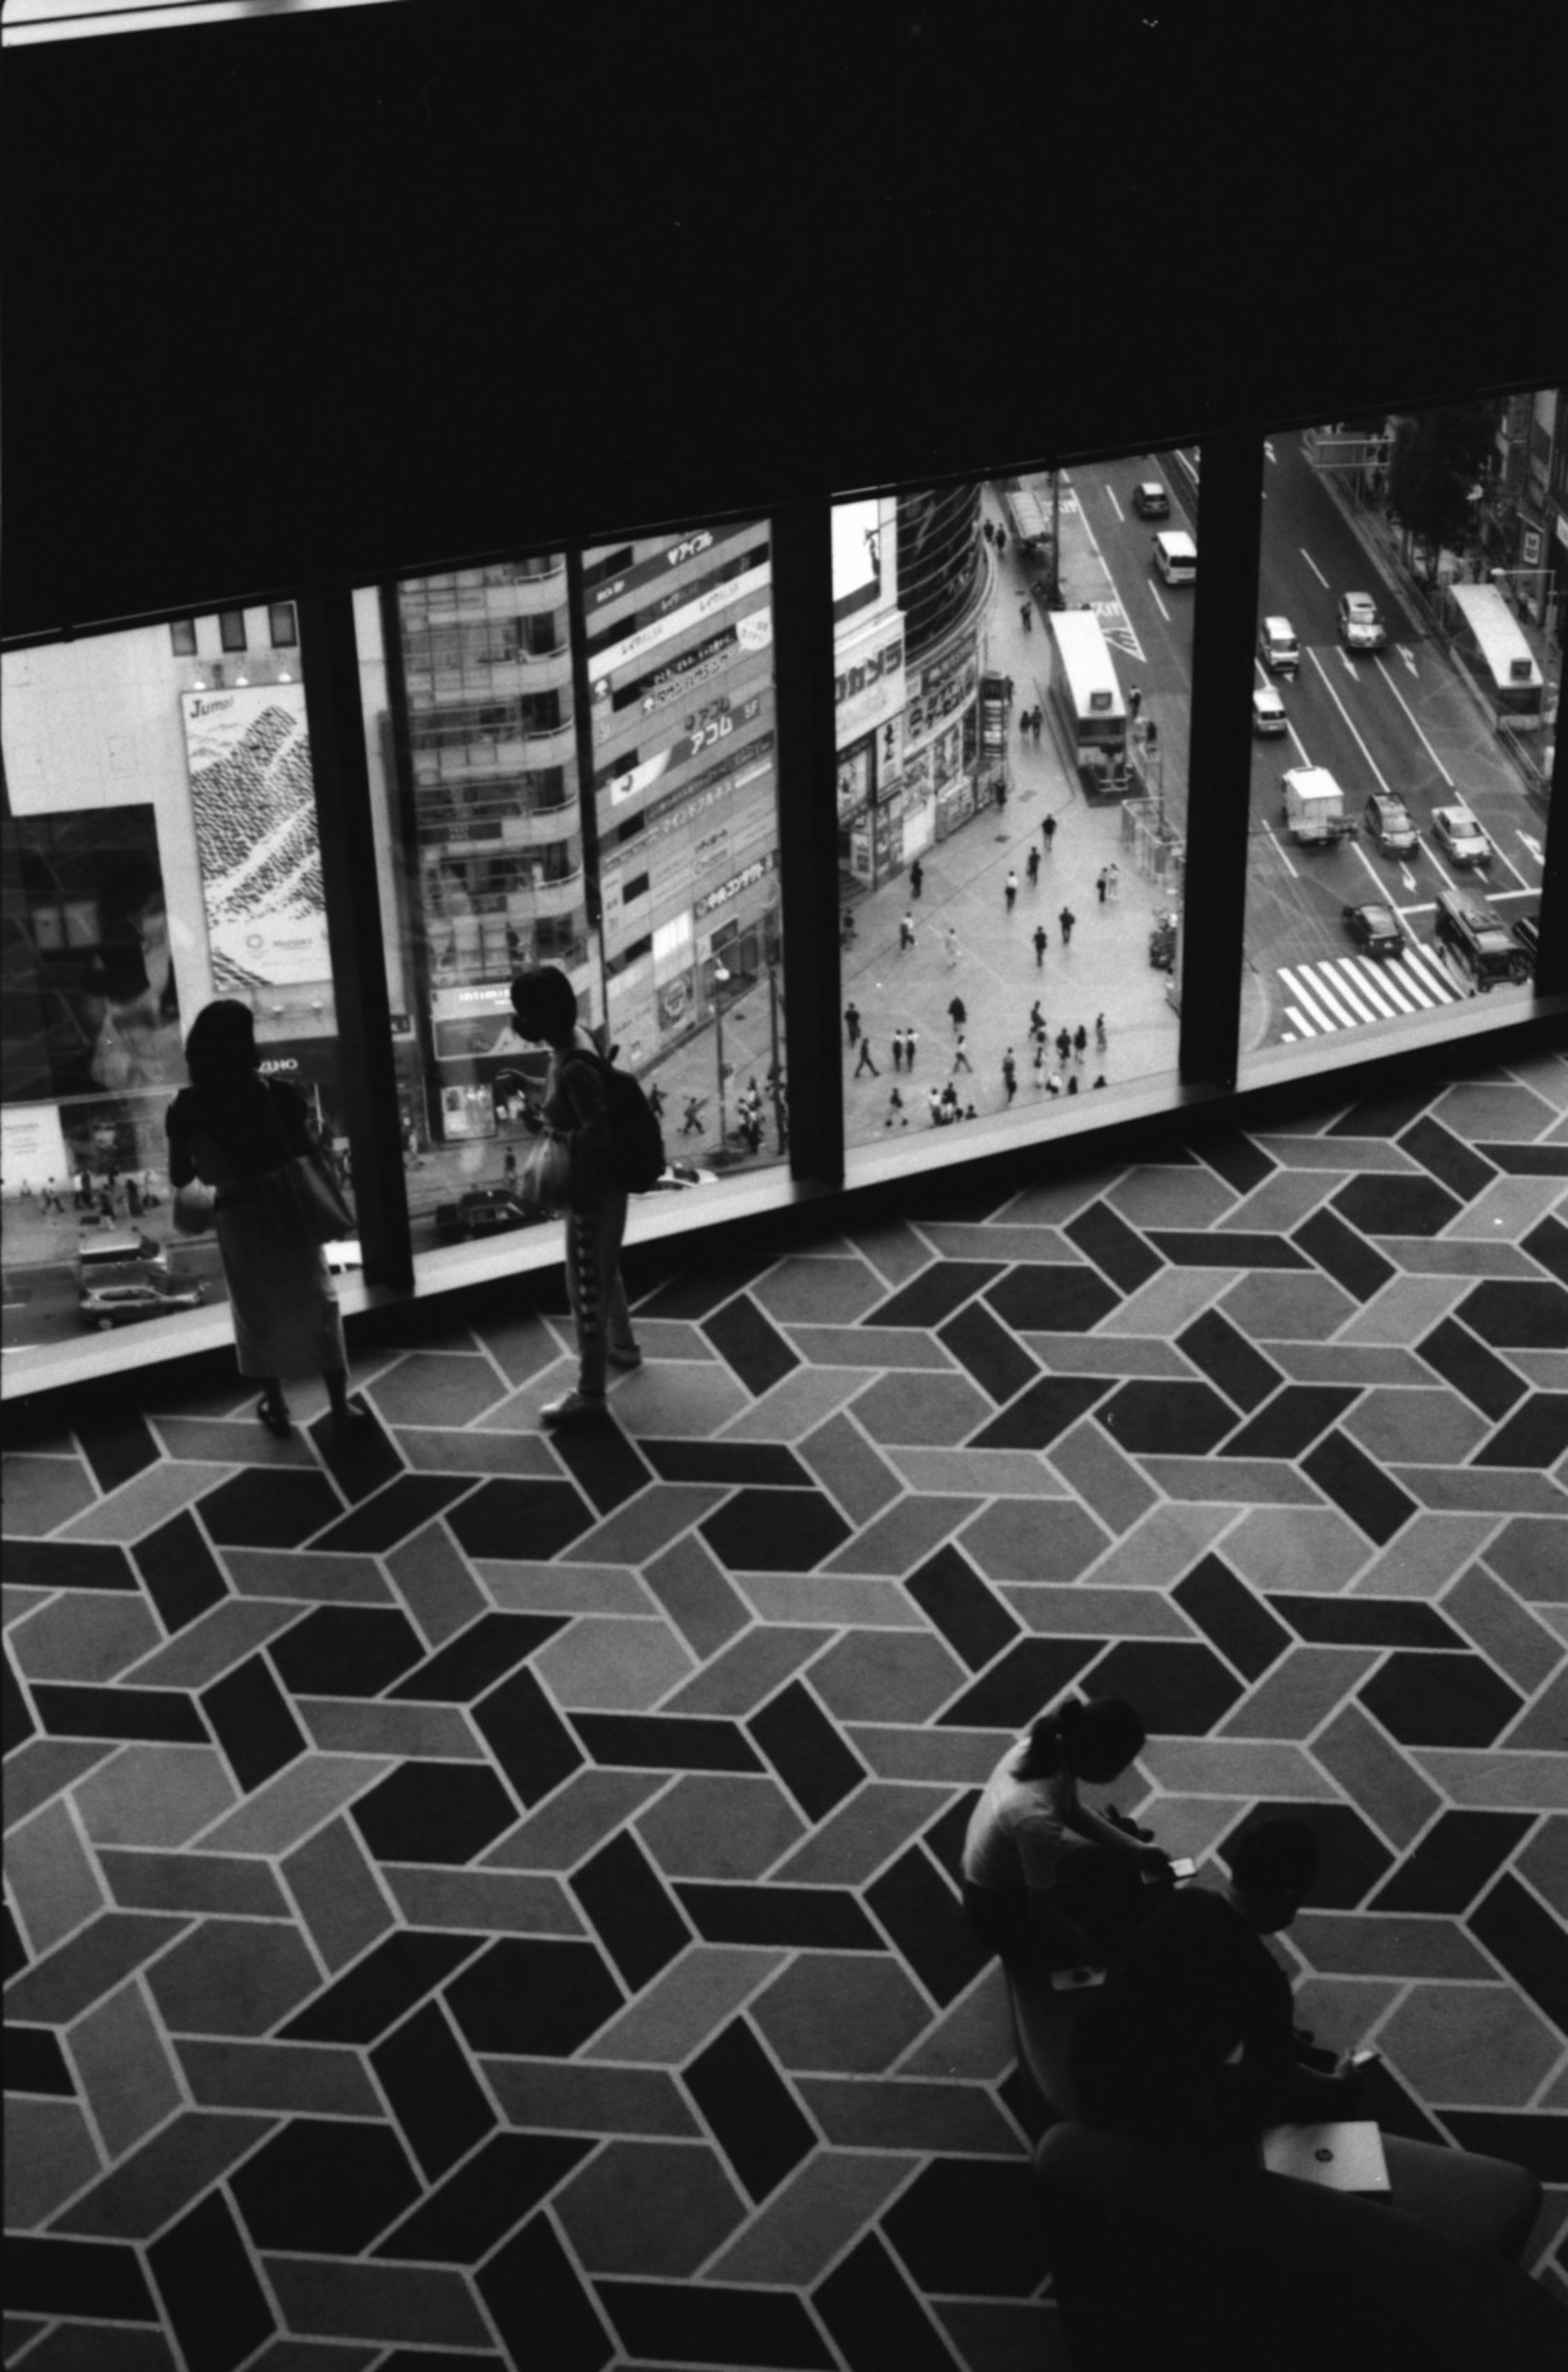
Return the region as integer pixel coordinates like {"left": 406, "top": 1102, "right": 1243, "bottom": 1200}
{"left": 963, "top": 1696, "right": 1169, "bottom": 1969}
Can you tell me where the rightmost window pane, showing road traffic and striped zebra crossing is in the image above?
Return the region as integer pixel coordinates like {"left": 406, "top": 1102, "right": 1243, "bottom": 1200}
{"left": 1243, "top": 389, "right": 1568, "bottom": 1072}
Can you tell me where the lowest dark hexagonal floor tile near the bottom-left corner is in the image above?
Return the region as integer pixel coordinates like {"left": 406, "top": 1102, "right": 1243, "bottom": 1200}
{"left": 228, "top": 2116, "right": 420, "bottom": 2256}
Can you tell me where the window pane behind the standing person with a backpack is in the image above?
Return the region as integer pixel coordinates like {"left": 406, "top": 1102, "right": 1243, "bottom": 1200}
{"left": 356, "top": 522, "right": 788, "bottom": 1253}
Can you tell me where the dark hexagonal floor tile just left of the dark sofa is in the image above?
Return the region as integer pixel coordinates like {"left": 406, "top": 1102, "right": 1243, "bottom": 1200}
{"left": 882, "top": 2158, "right": 1049, "bottom": 2298}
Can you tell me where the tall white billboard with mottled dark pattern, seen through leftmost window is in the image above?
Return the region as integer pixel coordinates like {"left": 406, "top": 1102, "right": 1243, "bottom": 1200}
{"left": 180, "top": 683, "right": 332, "bottom": 996}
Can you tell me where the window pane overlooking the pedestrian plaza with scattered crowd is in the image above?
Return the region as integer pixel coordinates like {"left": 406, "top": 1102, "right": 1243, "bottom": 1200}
{"left": 833, "top": 453, "right": 1198, "bottom": 1146}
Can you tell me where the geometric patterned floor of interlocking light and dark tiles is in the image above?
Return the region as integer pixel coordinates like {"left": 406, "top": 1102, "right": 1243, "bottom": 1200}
{"left": 5, "top": 1056, "right": 1568, "bottom": 2372}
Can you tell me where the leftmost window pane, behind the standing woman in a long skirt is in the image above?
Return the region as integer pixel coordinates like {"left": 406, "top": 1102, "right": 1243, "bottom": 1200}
{"left": 0, "top": 624, "right": 358, "bottom": 1369}
